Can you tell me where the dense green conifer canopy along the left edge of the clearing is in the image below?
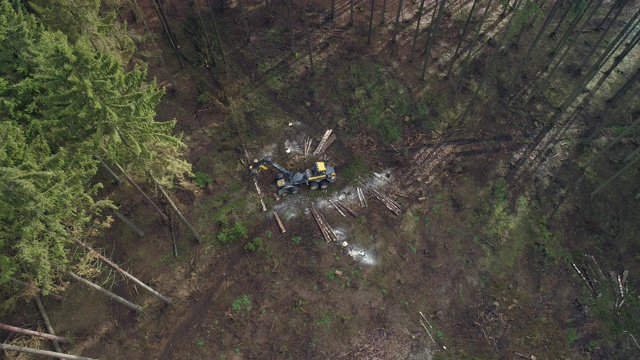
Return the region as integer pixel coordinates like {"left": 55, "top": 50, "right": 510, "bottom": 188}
{"left": 0, "top": 2, "right": 190, "bottom": 296}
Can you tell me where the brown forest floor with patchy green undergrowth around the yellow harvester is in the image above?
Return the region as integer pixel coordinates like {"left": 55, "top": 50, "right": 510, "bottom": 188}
{"left": 6, "top": 1, "right": 640, "bottom": 359}
